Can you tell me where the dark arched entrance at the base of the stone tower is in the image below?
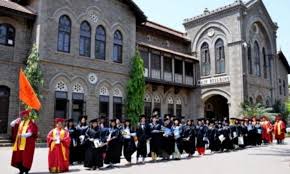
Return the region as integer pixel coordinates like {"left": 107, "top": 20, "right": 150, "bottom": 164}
{"left": 204, "top": 95, "right": 229, "bottom": 120}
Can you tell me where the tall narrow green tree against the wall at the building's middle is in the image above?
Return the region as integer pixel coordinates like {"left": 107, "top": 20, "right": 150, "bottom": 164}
{"left": 126, "top": 51, "right": 145, "bottom": 126}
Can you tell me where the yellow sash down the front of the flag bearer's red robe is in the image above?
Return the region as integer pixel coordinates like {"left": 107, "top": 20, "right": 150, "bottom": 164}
{"left": 13, "top": 120, "right": 30, "bottom": 151}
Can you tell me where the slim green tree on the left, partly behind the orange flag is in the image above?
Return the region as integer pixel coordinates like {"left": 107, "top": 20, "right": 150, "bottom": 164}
{"left": 24, "top": 45, "right": 44, "bottom": 119}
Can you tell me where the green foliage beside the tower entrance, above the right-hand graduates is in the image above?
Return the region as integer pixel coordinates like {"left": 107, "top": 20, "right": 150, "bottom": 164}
{"left": 241, "top": 101, "right": 272, "bottom": 118}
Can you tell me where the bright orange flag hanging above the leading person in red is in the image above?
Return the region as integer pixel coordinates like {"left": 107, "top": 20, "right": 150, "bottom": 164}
{"left": 19, "top": 69, "right": 41, "bottom": 111}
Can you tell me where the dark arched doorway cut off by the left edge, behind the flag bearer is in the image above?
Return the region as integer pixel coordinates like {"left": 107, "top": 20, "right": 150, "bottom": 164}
{"left": 0, "top": 86, "right": 10, "bottom": 134}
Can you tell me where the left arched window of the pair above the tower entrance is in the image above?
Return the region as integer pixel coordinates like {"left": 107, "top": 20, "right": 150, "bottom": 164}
{"left": 201, "top": 43, "right": 210, "bottom": 76}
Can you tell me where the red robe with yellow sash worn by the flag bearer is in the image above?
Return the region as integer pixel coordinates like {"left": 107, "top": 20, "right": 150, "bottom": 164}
{"left": 11, "top": 119, "right": 38, "bottom": 170}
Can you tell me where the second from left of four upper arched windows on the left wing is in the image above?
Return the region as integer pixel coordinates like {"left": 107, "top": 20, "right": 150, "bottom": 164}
{"left": 80, "top": 21, "right": 91, "bottom": 57}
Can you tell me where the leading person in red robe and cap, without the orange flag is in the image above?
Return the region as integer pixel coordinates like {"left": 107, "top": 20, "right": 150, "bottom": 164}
{"left": 10, "top": 110, "right": 38, "bottom": 174}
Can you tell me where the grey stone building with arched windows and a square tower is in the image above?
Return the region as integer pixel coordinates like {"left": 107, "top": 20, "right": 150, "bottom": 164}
{"left": 0, "top": 0, "right": 290, "bottom": 136}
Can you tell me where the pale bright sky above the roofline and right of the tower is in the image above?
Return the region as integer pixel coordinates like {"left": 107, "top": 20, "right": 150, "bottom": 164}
{"left": 134, "top": 0, "right": 290, "bottom": 65}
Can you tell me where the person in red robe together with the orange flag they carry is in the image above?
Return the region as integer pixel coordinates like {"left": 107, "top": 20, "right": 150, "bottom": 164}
{"left": 10, "top": 69, "right": 41, "bottom": 174}
